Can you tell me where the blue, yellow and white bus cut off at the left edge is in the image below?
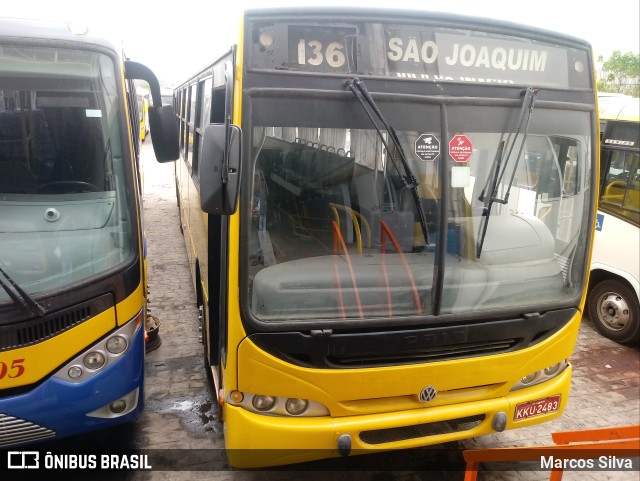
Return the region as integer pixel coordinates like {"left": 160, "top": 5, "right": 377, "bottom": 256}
{"left": 0, "top": 19, "right": 178, "bottom": 448}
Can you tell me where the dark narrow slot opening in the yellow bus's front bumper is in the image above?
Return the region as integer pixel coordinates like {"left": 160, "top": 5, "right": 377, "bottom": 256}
{"left": 360, "top": 414, "right": 485, "bottom": 444}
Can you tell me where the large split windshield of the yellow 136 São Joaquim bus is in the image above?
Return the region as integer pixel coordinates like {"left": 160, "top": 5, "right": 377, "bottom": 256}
{"left": 247, "top": 92, "right": 592, "bottom": 322}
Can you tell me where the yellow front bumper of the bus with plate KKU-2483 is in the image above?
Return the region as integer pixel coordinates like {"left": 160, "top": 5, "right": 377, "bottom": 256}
{"left": 224, "top": 366, "right": 572, "bottom": 468}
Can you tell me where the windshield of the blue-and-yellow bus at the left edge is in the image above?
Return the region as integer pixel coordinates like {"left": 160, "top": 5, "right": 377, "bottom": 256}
{"left": 0, "top": 45, "right": 135, "bottom": 301}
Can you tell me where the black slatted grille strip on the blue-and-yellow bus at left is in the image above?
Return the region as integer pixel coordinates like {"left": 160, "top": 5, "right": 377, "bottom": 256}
{"left": 0, "top": 294, "right": 113, "bottom": 352}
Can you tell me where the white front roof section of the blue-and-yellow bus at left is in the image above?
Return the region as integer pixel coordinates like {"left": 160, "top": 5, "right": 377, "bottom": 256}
{"left": 0, "top": 17, "right": 118, "bottom": 52}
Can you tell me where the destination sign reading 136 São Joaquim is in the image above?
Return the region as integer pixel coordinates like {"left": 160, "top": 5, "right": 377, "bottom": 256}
{"left": 249, "top": 22, "right": 590, "bottom": 88}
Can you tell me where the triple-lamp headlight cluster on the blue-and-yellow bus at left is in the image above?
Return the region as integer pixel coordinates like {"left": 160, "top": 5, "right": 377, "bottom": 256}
{"left": 55, "top": 311, "right": 142, "bottom": 382}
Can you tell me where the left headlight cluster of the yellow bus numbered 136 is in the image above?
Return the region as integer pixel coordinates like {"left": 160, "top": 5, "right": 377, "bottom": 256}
{"left": 227, "top": 391, "right": 329, "bottom": 417}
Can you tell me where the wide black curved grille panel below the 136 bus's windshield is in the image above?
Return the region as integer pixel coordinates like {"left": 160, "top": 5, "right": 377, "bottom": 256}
{"left": 249, "top": 308, "right": 577, "bottom": 369}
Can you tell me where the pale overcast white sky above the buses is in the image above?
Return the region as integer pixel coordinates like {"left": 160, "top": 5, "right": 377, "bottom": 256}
{"left": 0, "top": 0, "right": 640, "bottom": 86}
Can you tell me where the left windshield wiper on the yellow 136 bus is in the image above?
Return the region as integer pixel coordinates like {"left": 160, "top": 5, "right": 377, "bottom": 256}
{"left": 342, "top": 77, "right": 430, "bottom": 245}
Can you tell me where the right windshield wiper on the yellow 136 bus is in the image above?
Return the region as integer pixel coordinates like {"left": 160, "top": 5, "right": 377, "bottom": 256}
{"left": 476, "top": 87, "right": 540, "bottom": 259}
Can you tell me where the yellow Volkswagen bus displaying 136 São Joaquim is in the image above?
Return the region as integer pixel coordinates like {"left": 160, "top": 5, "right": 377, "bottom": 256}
{"left": 174, "top": 8, "right": 598, "bottom": 467}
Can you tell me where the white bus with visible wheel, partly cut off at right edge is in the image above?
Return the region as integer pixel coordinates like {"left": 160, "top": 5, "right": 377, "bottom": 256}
{"left": 587, "top": 94, "right": 640, "bottom": 344}
